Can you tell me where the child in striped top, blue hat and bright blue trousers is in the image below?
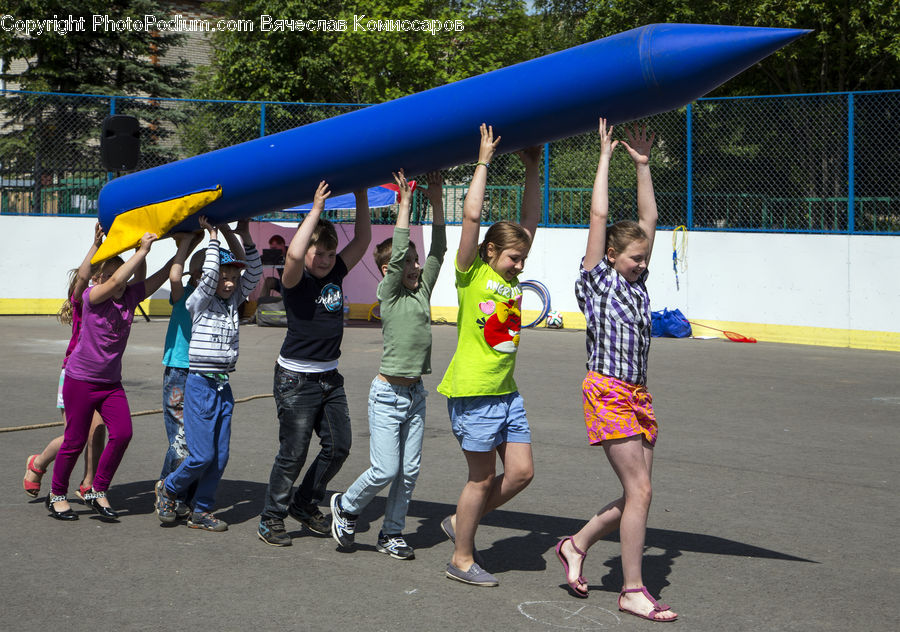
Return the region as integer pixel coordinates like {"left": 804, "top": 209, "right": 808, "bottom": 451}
{"left": 156, "top": 216, "right": 262, "bottom": 531}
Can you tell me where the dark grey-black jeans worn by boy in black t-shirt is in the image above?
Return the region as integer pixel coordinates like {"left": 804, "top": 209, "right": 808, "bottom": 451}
{"left": 262, "top": 365, "right": 353, "bottom": 520}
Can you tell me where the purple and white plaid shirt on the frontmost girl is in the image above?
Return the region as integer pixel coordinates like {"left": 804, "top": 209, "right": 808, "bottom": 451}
{"left": 575, "top": 257, "right": 650, "bottom": 385}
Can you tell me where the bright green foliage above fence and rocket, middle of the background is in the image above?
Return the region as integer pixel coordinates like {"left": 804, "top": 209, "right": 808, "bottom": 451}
{"left": 198, "top": 0, "right": 534, "bottom": 103}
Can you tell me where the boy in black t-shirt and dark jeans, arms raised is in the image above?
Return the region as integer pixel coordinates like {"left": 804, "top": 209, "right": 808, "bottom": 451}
{"left": 257, "top": 180, "right": 372, "bottom": 546}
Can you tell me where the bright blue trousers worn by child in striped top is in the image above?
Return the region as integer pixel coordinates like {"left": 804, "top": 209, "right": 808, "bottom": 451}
{"left": 165, "top": 373, "right": 234, "bottom": 512}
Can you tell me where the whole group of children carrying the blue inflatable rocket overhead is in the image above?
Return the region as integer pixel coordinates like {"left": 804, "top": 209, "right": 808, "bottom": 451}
{"left": 24, "top": 119, "right": 677, "bottom": 621}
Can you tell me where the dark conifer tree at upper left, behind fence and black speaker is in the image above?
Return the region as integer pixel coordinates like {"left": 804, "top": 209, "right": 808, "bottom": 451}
{"left": 0, "top": 0, "right": 188, "bottom": 212}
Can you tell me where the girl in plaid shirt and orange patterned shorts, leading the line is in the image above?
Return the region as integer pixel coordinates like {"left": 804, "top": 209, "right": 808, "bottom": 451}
{"left": 556, "top": 118, "right": 678, "bottom": 621}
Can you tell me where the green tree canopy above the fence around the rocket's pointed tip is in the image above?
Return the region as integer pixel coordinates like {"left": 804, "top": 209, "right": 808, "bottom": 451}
{"left": 536, "top": 0, "right": 900, "bottom": 96}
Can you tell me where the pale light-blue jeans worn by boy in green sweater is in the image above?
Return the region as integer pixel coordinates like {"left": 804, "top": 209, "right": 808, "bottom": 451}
{"left": 341, "top": 377, "right": 428, "bottom": 534}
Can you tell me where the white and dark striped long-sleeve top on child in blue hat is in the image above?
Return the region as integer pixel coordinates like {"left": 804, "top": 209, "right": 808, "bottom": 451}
{"left": 186, "top": 239, "right": 262, "bottom": 373}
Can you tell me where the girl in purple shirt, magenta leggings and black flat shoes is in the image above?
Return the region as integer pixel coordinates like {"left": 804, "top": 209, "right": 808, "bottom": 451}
{"left": 47, "top": 233, "right": 172, "bottom": 520}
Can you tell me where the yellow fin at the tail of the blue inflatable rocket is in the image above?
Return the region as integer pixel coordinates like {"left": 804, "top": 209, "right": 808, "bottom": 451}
{"left": 91, "top": 186, "right": 222, "bottom": 263}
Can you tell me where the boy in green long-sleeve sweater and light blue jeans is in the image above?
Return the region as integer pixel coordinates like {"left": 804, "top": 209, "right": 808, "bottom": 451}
{"left": 331, "top": 169, "right": 447, "bottom": 560}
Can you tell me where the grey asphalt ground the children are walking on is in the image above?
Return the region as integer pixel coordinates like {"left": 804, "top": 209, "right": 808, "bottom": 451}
{"left": 0, "top": 317, "right": 900, "bottom": 631}
